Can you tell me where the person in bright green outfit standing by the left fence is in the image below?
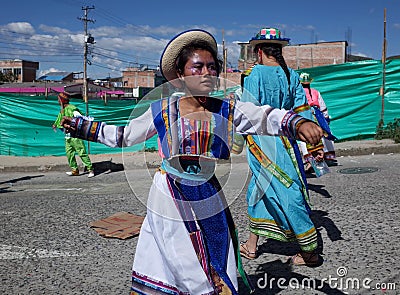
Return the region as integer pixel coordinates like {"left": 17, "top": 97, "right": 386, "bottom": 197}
{"left": 52, "top": 92, "right": 94, "bottom": 178}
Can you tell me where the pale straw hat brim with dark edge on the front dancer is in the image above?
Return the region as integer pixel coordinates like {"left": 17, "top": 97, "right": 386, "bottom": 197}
{"left": 160, "top": 29, "right": 218, "bottom": 81}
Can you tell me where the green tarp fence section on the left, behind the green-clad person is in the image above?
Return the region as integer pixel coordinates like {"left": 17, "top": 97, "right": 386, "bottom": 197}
{"left": 0, "top": 94, "right": 157, "bottom": 156}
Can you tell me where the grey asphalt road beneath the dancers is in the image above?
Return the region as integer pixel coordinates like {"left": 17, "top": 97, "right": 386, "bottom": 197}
{"left": 0, "top": 154, "right": 400, "bottom": 295}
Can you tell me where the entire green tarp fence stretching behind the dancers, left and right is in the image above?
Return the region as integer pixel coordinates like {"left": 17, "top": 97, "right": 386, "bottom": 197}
{"left": 0, "top": 60, "right": 400, "bottom": 156}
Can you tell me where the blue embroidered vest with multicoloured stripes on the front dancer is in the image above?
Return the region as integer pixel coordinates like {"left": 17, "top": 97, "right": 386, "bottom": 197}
{"left": 151, "top": 96, "right": 235, "bottom": 159}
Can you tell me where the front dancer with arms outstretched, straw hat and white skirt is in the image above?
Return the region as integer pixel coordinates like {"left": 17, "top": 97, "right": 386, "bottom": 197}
{"left": 63, "top": 29, "right": 323, "bottom": 294}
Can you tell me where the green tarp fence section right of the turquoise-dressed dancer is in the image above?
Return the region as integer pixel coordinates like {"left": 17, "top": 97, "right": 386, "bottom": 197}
{"left": 298, "top": 60, "right": 400, "bottom": 141}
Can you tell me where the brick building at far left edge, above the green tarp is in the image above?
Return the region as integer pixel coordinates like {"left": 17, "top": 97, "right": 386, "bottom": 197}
{"left": 0, "top": 59, "right": 39, "bottom": 83}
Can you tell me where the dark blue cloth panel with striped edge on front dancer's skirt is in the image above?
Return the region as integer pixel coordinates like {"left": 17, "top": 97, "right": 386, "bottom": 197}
{"left": 167, "top": 175, "right": 237, "bottom": 294}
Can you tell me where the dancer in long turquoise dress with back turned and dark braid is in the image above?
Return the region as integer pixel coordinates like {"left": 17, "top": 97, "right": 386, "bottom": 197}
{"left": 240, "top": 27, "right": 321, "bottom": 266}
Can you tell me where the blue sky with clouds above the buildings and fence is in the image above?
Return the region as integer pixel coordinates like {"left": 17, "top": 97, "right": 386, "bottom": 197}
{"left": 0, "top": 0, "right": 400, "bottom": 79}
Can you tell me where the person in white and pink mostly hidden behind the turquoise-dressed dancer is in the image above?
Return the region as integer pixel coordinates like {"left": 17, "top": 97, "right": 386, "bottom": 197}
{"left": 300, "top": 72, "right": 337, "bottom": 170}
